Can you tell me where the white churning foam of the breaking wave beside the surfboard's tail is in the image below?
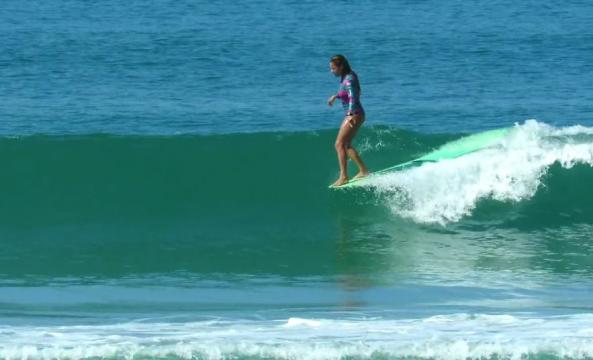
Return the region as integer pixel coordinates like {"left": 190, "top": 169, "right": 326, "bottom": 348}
{"left": 369, "top": 120, "right": 593, "bottom": 224}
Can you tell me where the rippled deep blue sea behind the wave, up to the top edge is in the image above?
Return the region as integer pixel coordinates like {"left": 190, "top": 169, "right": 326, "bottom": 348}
{"left": 0, "top": 1, "right": 593, "bottom": 135}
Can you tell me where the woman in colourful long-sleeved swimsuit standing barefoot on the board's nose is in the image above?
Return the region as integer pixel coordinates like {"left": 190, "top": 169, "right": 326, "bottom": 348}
{"left": 327, "top": 55, "right": 369, "bottom": 186}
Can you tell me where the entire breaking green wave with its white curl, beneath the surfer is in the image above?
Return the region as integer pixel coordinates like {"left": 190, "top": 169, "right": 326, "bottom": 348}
{"left": 0, "top": 120, "right": 593, "bottom": 278}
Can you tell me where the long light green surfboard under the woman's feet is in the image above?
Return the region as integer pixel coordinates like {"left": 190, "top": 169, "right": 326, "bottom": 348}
{"left": 329, "top": 127, "right": 512, "bottom": 189}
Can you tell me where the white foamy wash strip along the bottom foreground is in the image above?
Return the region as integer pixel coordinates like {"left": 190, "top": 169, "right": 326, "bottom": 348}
{"left": 0, "top": 314, "right": 593, "bottom": 360}
